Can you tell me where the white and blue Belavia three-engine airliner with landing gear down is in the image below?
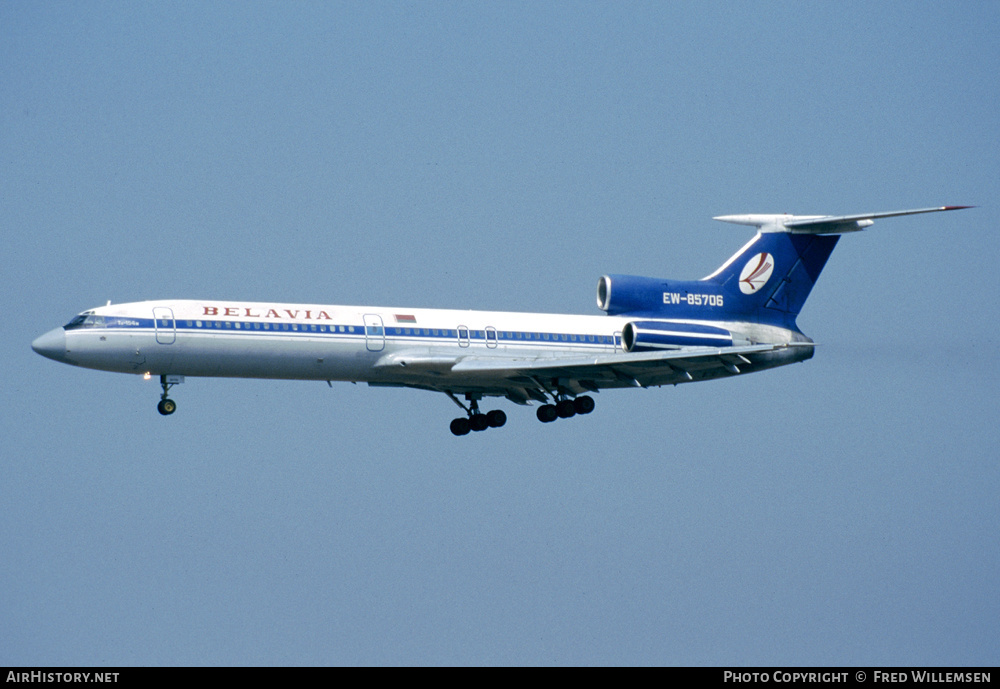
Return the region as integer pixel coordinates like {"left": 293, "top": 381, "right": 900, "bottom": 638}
{"left": 31, "top": 206, "right": 971, "bottom": 436}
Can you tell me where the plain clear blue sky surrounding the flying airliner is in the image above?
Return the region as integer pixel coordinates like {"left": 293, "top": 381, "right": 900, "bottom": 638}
{"left": 0, "top": 1, "right": 1000, "bottom": 665}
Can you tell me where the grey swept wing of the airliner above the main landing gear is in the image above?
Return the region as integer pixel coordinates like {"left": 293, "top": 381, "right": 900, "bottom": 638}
{"left": 370, "top": 342, "right": 814, "bottom": 404}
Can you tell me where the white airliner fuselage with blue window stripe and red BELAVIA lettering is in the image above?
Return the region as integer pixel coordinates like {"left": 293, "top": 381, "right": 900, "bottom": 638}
{"left": 34, "top": 300, "right": 797, "bottom": 388}
